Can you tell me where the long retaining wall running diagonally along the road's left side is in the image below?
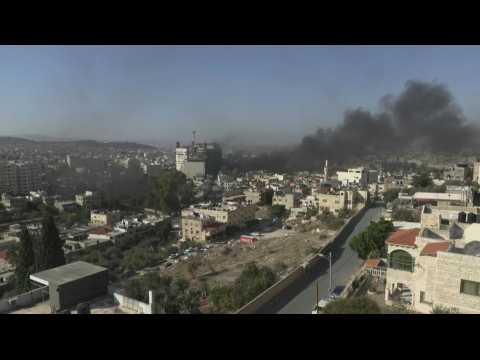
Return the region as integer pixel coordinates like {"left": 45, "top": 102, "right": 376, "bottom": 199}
{"left": 236, "top": 207, "right": 367, "bottom": 314}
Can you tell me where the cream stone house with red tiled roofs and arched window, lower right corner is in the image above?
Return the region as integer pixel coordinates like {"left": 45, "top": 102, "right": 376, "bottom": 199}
{"left": 385, "top": 207, "right": 480, "bottom": 313}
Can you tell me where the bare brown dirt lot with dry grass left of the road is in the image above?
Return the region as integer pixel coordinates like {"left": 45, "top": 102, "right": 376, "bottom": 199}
{"left": 161, "top": 219, "right": 335, "bottom": 285}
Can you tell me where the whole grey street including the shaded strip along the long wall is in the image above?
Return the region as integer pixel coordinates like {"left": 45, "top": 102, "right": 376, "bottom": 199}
{"left": 253, "top": 204, "right": 383, "bottom": 314}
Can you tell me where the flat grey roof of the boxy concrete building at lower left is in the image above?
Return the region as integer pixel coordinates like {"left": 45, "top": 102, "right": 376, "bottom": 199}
{"left": 30, "top": 261, "right": 107, "bottom": 286}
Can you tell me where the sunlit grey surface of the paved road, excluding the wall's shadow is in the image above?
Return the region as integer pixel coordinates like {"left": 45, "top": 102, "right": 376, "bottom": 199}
{"left": 277, "top": 206, "right": 383, "bottom": 314}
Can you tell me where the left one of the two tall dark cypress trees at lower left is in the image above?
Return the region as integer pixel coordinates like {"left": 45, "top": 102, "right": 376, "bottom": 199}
{"left": 12, "top": 226, "right": 35, "bottom": 292}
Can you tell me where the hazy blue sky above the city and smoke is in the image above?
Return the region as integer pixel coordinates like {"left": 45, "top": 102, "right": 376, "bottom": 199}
{"left": 0, "top": 46, "right": 480, "bottom": 143}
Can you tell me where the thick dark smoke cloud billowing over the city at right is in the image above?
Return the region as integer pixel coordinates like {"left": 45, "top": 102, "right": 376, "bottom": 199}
{"left": 225, "top": 80, "right": 480, "bottom": 173}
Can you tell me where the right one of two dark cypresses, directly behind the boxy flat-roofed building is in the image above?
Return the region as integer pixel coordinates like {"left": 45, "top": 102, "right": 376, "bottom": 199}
{"left": 37, "top": 215, "right": 65, "bottom": 270}
